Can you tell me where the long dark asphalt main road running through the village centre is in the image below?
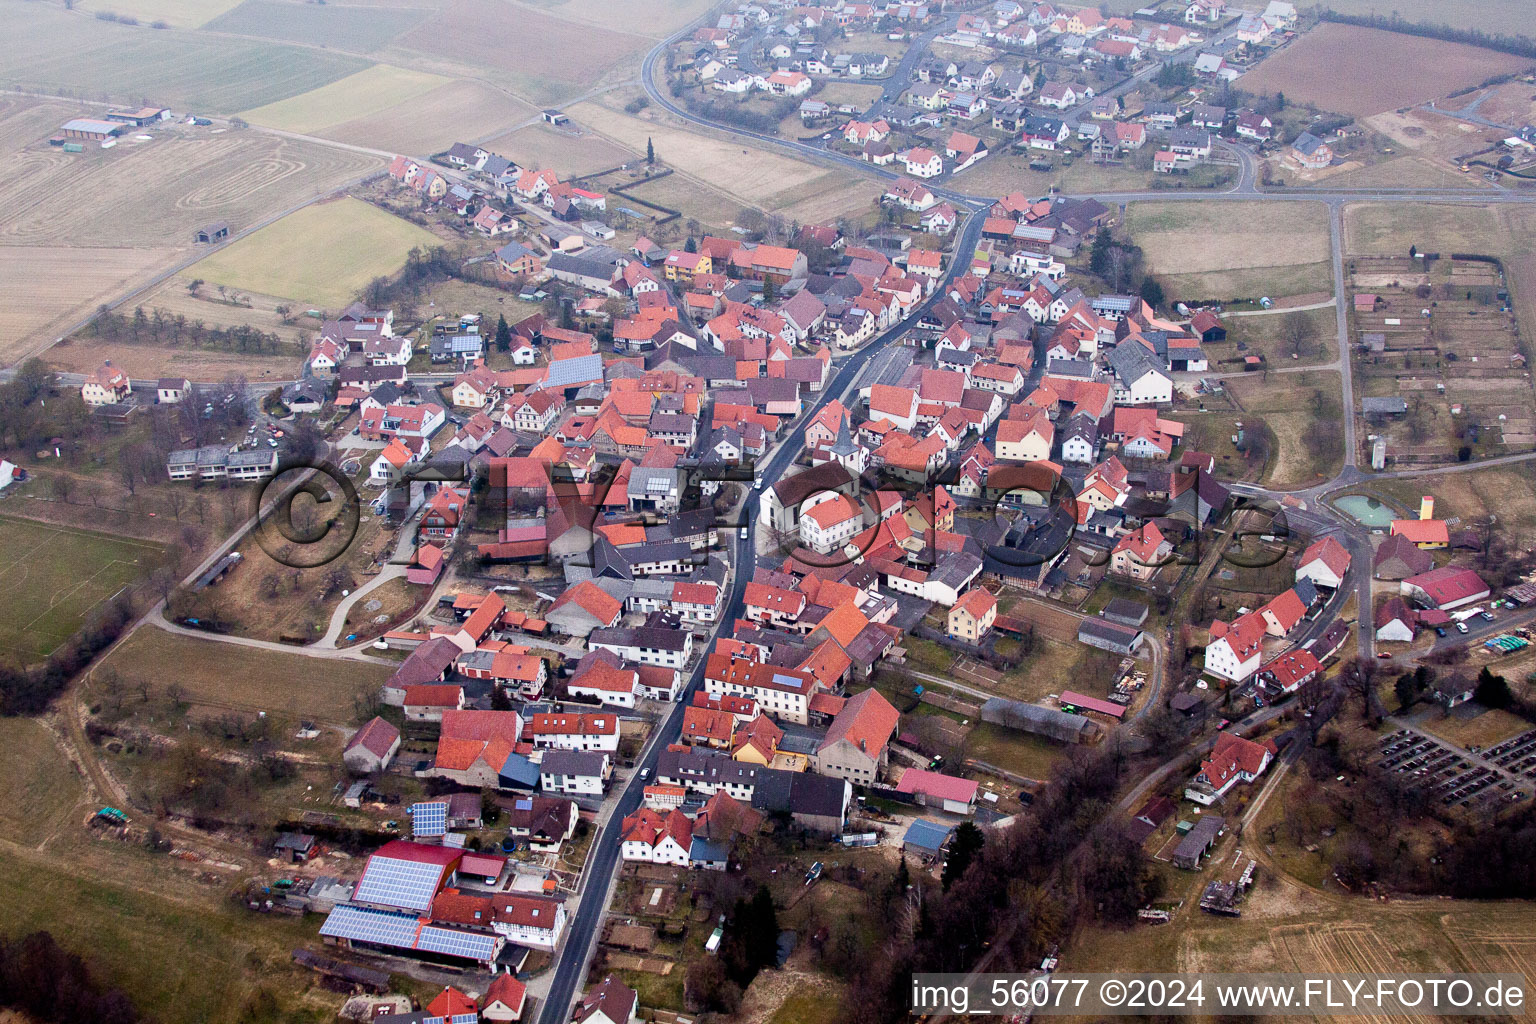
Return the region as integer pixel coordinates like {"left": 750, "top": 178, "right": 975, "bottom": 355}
{"left": 539, "top": 212, "right": 983, "bottom": 1024}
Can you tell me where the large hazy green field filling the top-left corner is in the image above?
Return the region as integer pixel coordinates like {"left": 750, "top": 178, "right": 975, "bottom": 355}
{"left": 0, "top": 0, "right": 367, "bottom": 114}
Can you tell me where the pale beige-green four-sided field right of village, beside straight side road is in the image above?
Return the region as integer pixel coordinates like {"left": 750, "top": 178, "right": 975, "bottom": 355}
{"left": 1126, "top": 201, "right": 1332, "bottom": 299}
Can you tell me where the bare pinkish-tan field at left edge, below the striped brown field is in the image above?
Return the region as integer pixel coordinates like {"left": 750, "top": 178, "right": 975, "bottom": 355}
{"left": 0, "top": 246, "right": 175, "bottom": 368}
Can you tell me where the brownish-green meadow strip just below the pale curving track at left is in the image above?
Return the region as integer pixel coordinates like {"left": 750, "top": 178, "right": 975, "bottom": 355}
{"left": 94, "top": 626, "right": 390, "bottom": 723}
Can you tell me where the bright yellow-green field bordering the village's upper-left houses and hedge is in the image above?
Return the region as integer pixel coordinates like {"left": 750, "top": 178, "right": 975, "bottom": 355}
{"left": 194, "top": 198, "right": 436, "bottom": 309}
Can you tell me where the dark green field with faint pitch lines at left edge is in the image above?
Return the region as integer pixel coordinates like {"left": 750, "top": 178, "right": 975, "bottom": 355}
{"left": 0, "top": 516, "right": 164, "bottom": 663}
